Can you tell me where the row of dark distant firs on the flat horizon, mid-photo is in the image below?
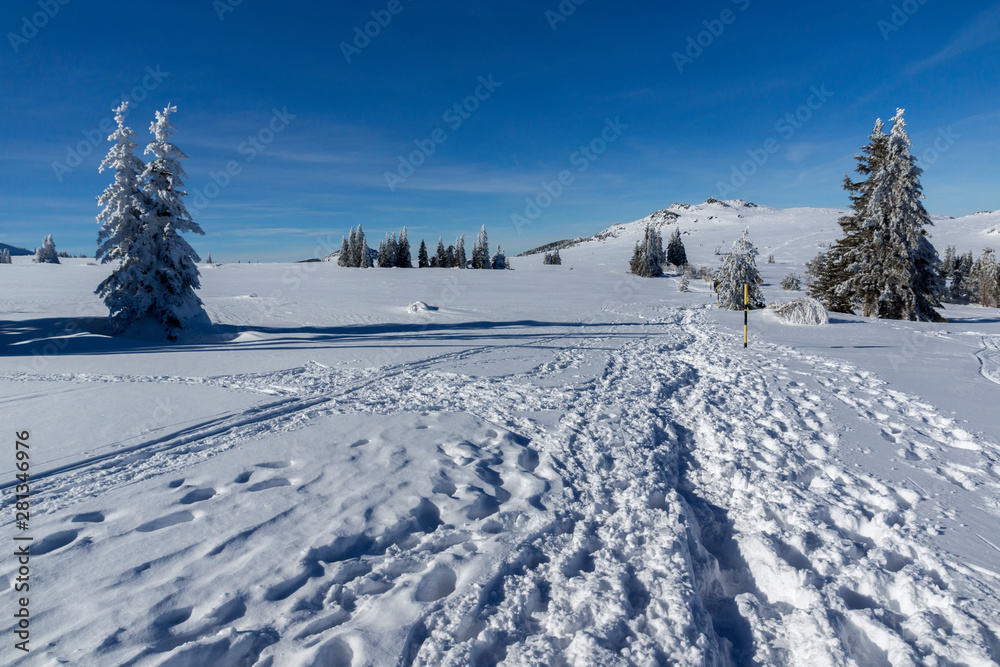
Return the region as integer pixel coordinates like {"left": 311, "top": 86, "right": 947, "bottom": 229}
{"left": 337, "top": 225, "right": 511, "bottom": 269}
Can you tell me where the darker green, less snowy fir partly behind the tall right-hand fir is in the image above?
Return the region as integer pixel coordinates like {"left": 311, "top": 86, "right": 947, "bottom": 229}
{"left": 806, "top": 119, "right": 889, "bottom": 313}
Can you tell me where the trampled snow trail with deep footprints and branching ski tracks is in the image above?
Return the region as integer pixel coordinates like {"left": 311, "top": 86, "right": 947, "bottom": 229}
{"left": 0, "top": 308, "right": 1000, "bottom": 666}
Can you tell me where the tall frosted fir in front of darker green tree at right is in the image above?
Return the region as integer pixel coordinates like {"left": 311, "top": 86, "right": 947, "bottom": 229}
{"left": 838, "top": 109, "right": 942, "bottom": 322}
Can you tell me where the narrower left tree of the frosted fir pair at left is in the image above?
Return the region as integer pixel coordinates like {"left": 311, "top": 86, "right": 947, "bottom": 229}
{"left": 94, "top": 102, "right": 146, "bottom": 332}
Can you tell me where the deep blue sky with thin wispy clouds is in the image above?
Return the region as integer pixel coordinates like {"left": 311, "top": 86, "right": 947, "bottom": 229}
{"left": 0, "top": 0, "right": 1000, "bottom": 261}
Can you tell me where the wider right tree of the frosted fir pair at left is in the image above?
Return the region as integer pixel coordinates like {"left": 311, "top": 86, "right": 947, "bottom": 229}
{"left": 125, "top": 105, "right": 208, "bottom": 339}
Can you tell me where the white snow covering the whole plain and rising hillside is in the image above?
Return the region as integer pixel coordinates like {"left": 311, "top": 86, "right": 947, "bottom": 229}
{"left": 0, "top": 204, "right": 1000, "bottom": 667}
